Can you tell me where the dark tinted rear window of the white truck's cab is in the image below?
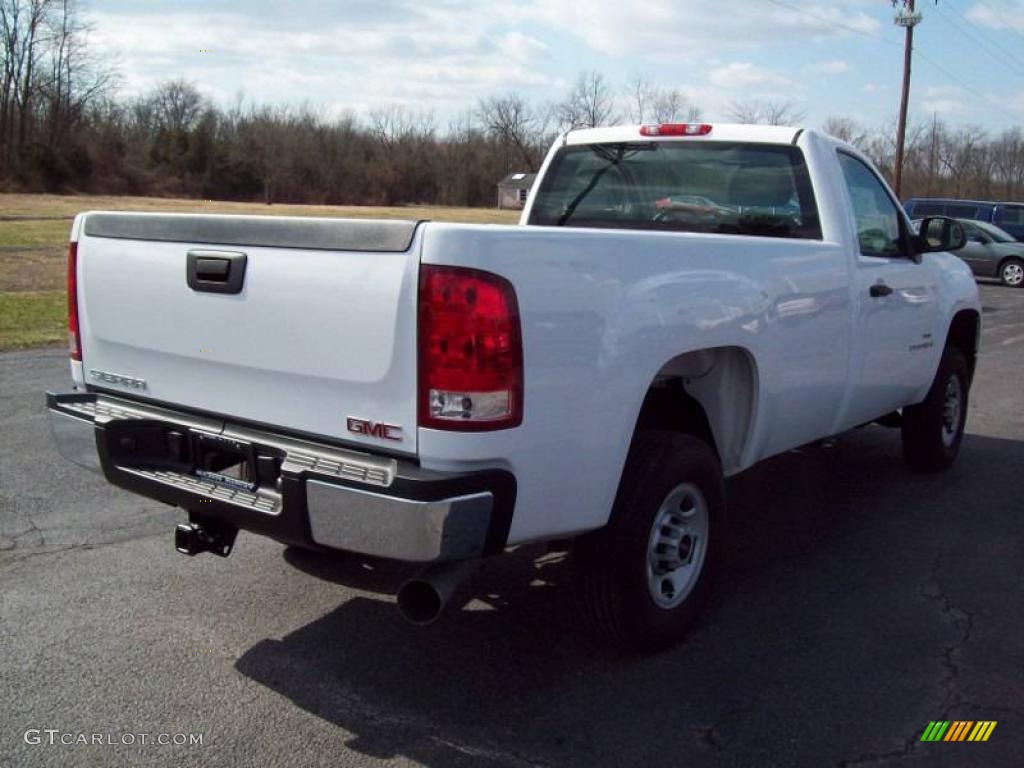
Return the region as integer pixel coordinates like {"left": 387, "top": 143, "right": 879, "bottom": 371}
{"left": 529, "top": 141, "right": 821, "bottom": 239}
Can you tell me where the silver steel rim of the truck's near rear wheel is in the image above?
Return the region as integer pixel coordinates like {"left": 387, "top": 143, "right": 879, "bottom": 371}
{"left": 647, "top": 482, "right": 709, "bottom": 609}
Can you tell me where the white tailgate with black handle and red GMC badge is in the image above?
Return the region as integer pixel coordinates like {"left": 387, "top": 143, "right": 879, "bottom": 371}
{"left": 76, "top": 213, "right": 420, "bottom": 454}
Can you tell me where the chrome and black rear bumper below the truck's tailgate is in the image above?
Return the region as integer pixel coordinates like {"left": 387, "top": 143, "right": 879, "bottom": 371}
{"left": 47, "top": 393, "right": 515, "bottom": 562}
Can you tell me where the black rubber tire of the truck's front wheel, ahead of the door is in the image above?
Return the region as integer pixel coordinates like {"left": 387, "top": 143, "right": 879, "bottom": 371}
{"left": 902, "top": 347, "right": 970, "bottom": 472}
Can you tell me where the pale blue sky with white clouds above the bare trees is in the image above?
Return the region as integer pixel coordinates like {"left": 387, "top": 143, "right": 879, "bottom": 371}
{"left": 85, "top": 0, "right": 1024, "bottom": 132}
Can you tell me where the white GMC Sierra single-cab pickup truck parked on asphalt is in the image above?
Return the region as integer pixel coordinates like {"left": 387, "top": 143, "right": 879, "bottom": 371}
{"left": 48, "top": 124, "right": 980, "bottom": 649}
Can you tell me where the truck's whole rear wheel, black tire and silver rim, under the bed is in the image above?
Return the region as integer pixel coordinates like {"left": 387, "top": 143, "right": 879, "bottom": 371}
{"left": 572, "top": 430, "right": 725, "bottom": 651}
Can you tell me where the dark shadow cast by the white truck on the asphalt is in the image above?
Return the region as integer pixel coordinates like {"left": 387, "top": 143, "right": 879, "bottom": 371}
{"left": 236, "top": 428, "right": 1024, "bottom": 768}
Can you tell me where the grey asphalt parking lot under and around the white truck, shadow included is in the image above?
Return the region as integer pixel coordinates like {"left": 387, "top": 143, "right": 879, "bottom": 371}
{"left": 0, "top": 285, "right": 1024, "bottom": 768}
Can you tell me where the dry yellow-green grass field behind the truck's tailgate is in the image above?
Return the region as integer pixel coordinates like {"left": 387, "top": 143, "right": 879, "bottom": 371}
{"left": 0, "top": 194, "right": 518, "bottom": 350}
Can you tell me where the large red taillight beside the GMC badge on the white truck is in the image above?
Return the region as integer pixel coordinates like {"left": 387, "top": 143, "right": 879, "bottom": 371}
{"left": 419, "top": 264, "right": 523, "bottom": 431}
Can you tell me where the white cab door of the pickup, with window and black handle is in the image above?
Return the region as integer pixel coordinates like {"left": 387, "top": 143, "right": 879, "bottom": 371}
{"left": 840, "top": 152, "right": 944, "bottom": 426}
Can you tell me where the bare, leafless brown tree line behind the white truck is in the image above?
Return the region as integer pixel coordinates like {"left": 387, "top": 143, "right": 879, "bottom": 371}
{"left": 0, "top": 0, "right": 1024, "bottom": 206}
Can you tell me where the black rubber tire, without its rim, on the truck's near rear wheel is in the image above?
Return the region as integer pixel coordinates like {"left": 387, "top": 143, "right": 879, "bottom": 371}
{"left": 571, "top": 430, "right": 725, "bottom": 652}
